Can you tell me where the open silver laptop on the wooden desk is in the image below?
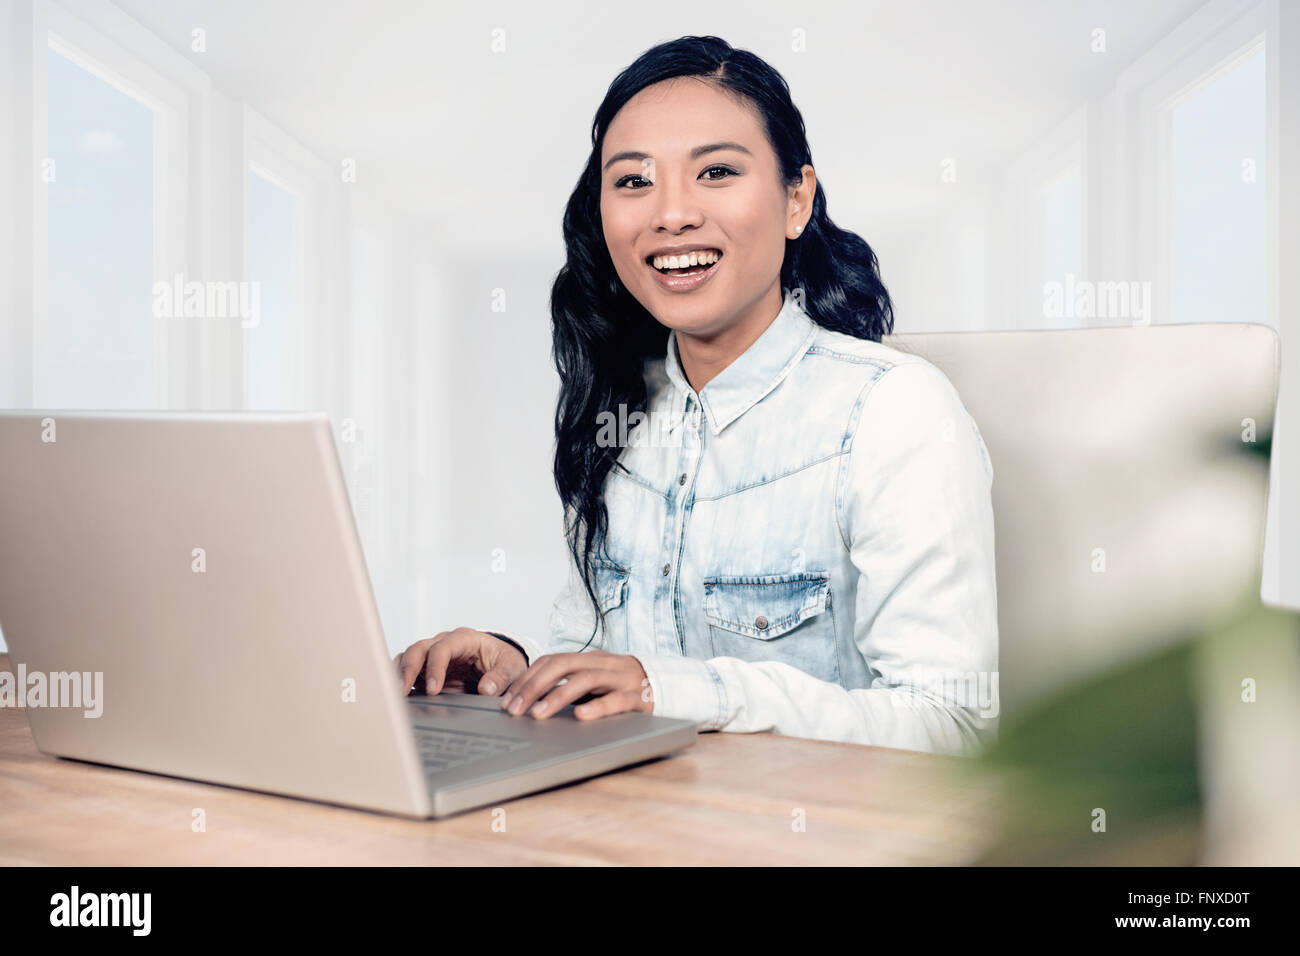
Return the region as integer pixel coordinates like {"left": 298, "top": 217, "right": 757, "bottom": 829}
{"left": 0, "top": 411, "right": 696, "bottom": 818}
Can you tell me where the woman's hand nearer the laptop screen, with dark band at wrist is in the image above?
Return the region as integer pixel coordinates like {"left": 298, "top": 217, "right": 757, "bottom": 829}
{"left": 393, "top": 627, "right": 527, "bottom": 696}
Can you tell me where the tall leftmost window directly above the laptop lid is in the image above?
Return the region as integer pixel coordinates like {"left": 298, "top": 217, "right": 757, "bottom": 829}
{"left": 45, "top": 49, "right": 156, "bottom": 408}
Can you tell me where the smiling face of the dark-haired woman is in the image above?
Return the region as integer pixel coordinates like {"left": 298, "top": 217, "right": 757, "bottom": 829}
{"left": 601, "top": 78, "right": 815, "bottom": 338}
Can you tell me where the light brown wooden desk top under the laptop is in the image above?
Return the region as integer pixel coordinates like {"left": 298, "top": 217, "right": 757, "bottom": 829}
{"left": 0, "top": 654, "right": 996, "bottom": 866}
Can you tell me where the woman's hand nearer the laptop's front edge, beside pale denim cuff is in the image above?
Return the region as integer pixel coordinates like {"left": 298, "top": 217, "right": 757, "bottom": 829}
{"left": 501, "top": 650, "right": 654, "bottom": 721}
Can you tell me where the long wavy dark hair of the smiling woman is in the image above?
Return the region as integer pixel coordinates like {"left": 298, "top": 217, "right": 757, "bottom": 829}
{"left": 551, "top": 36, "right": 893, "bottom": 644}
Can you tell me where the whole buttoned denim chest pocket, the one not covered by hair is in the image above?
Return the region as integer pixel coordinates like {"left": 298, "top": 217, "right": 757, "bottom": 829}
{"left": 703, "top": 571, "right": 840, "bottom": 683}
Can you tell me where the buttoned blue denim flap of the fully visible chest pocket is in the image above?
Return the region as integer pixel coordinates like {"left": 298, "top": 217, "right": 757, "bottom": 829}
{"left": 703, "top": 571, "right": 831, "bottom": 641}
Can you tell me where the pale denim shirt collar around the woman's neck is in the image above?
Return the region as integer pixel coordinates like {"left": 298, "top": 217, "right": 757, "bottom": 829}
{"left": 664, "top": 291, "right": 816, "bottom": 434}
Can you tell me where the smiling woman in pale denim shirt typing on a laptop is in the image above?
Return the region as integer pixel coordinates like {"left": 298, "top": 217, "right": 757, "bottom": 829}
{"left": 398, "top": 36, "right": 997, "bottom": 753}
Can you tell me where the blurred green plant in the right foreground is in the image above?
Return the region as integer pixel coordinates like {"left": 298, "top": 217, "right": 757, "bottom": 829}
{"left": 958, "top": 437, "right": 1300, "bottom": 866}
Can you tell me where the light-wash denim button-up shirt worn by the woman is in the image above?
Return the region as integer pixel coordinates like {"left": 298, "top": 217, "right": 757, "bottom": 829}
{"left": 506, "top": 293, "right": 998, "bottom": 754}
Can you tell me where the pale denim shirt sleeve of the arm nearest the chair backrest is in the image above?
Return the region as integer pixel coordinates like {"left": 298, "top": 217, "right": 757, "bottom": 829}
{"left": 636, "top": 360, "right": 998, "bottom": 756}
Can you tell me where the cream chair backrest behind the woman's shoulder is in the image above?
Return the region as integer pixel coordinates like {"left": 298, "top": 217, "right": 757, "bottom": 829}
{"left": 884, "top": 323, "right": 1279, "bottom": 714}
